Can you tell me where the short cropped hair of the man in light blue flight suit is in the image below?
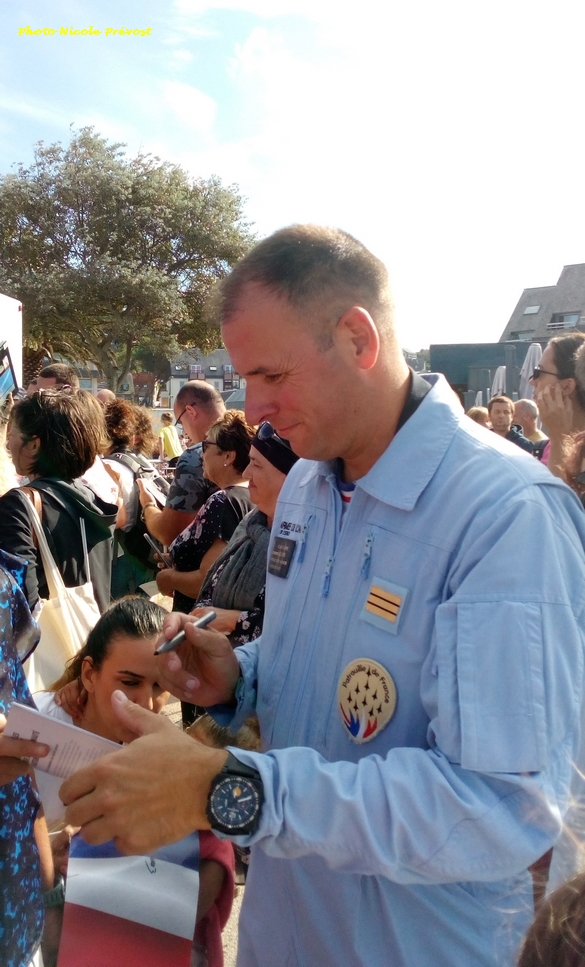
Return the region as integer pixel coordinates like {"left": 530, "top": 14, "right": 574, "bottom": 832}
{"left": 218, "top": 225, "right": 394, "bottom": 348}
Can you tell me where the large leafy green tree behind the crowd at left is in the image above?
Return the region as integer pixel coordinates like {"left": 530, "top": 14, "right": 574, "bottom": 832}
{"left": 0, "top": 128, "right": 253, "bottom": 390}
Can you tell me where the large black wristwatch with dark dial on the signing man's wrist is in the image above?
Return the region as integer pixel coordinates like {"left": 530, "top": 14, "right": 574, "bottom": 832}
{"left": 207, "top": 752, "right": 264, "bottom": 836}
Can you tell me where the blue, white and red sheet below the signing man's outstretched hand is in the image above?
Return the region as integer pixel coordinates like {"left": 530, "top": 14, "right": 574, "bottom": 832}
{"left": 58, "top": 833, "right": 199, "bottom": 967}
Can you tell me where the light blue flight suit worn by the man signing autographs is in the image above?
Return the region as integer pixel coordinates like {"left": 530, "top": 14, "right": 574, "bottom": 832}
{"left": 217, "top": 375, "right": 585, "bottom": 967}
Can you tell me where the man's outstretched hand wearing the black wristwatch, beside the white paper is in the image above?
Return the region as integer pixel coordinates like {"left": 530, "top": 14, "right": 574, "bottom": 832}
{"left": 59, "top": 691, "right": 227, "bottom": 854}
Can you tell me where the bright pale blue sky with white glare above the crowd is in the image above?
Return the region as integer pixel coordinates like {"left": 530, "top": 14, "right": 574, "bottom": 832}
{"left": 0, "top": 0, "right": 585, "bottom": 349}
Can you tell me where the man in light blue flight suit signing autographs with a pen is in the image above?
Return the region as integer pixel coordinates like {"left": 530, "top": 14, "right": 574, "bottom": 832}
{"left": 62, "top": 226, "right": 585, "bottom": 967}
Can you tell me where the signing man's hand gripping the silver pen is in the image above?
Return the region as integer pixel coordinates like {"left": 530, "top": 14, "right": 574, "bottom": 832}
{"left": 157, "top": 613, "right": 240, "bottom": 707}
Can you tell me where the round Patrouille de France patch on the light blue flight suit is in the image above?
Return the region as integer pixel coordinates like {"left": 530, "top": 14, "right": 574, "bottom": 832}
{"left": 337, "top": 658, "right": 398, "bottom": 743}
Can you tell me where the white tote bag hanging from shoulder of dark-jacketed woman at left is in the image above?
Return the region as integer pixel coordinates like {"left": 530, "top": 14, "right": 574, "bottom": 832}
{"left": 24, "top": 501, "right": 100, "bottom": 692}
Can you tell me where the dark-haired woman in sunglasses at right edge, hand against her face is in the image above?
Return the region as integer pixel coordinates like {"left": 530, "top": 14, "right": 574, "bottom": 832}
{"left": 530, "top": 332, "right": 585, "bottom": 477}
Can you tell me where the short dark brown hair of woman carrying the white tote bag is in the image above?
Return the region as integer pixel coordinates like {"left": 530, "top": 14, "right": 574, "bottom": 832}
{"left": 11, "top": 390, "right": 105, "bottom": 480}
